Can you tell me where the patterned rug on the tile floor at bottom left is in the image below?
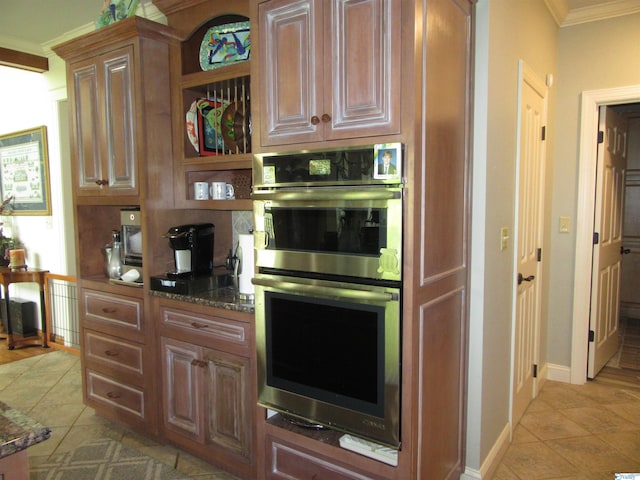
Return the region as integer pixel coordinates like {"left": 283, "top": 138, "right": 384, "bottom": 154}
{"left": 30, "top": 439, "right": 190, "bottom": 480}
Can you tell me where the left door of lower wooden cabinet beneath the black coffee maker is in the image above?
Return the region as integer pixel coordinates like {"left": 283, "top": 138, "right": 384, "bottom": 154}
{"left": 161, "top": 337, "right": 203, "bottom": 441}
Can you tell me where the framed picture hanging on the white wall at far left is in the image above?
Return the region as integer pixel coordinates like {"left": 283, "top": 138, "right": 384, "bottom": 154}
{"left": 0, "top": 125, "right": 51, "bottom": 215}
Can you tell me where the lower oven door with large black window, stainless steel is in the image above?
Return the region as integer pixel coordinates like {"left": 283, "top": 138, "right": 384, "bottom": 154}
{"left": 254, "top": 274, "right": 400, "bottom": 447}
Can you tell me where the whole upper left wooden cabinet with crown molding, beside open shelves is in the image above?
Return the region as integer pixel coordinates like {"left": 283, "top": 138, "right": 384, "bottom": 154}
{"left": 53, "top": 17, "right": 174, "bottom": 204}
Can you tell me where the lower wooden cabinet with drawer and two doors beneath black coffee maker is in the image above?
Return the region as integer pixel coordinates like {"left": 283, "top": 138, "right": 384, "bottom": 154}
{"left": 159, "top": 301, "right": 257, "bottom": 478}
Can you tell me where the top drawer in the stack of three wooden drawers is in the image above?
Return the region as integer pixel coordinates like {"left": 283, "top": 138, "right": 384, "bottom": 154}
{"left": 81, "top": 290, "right": 142, "bottom": 332}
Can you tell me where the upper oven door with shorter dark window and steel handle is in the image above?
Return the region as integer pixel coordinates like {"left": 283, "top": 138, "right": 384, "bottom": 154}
{"left": 254, "top": 187, "right": 402, "bottom": 281}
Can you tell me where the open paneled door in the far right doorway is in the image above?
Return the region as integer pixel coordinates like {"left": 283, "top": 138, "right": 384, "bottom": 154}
{"left": 587, "top": 106, "right": 627, "bottom": 378}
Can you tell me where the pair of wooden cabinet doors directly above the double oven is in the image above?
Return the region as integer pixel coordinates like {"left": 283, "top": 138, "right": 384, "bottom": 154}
{"left": 257, "top": 0, "right": 401, "bottom": 146}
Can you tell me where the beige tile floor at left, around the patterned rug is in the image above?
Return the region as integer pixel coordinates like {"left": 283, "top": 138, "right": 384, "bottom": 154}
{"left": 0, "top": 351, "right": 236, "bottom": 480}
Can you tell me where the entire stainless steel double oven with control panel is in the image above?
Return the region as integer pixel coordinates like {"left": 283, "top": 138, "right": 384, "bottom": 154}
{"left": 254, "top": 144, "right": 403, "bottom": 448}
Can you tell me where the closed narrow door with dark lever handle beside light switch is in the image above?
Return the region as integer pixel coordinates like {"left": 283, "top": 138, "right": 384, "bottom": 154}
{"left": 512, "top": 62, "right": 547, "bottom": 425}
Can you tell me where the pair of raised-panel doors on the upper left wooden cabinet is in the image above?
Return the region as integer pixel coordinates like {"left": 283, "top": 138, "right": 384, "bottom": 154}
{"left": 70, "top": 46, "right": 138, "bottom": 196}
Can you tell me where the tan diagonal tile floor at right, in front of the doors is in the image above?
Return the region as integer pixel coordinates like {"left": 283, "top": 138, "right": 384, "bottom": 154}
{"left": 492, "top": 378, "right": 640, "bottom": 480}
